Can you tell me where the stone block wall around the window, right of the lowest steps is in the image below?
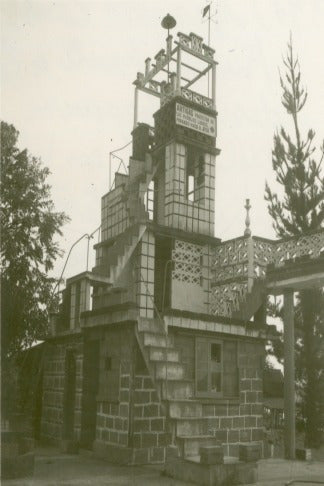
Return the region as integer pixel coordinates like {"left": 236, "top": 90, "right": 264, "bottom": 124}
{"left": 174, "top": 332, "right": 264, "bottom": 457}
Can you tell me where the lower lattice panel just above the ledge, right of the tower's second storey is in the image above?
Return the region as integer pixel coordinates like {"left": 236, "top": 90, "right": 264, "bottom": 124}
{"left": 210, "top": 282, "right": 248, "bottom": 317}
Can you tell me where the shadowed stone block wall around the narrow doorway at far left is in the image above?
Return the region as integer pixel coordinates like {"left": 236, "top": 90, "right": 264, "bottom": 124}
{"left": 41, "top": 338, "right": 83, "bottom": 442}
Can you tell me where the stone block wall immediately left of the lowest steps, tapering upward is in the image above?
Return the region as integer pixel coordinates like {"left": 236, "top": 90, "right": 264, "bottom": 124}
{"left": 94, "top": 329, "right": 171, "bottom": 464}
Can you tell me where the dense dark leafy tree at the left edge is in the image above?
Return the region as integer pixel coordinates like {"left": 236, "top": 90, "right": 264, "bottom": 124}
{"left": 0, "top": 122, "right": 68, "bottom": 414}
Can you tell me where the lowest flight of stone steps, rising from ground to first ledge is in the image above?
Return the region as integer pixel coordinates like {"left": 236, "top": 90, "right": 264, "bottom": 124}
{"left": 137, "top": 318, "right": 218, "bottom": 458}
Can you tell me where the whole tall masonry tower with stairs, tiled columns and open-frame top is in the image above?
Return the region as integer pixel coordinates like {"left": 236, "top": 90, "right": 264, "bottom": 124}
{"left": 41, "top": 18, "right": 278, "bottom": 470}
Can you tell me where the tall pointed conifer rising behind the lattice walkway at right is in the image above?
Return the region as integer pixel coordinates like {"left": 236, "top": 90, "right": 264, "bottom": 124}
{"left": 265, "top": 41, "right": 324, "bottom": 447}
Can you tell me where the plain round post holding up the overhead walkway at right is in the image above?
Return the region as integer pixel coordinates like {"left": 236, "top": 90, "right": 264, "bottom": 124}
{"left": 283, "top": 289, "right": 296, "bottom": 459}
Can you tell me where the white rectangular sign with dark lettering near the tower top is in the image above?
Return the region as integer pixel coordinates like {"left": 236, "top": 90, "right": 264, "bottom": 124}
{"left": 176, "top": 103, "right": 216, "bottom": 137}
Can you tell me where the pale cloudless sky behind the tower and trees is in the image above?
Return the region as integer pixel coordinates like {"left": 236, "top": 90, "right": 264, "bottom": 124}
{"left": 0, "top": 0, "right": 324, "bottom": 277}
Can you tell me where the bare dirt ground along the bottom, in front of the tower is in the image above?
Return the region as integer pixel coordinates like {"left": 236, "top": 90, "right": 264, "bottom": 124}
{"left": 2, "top": 448, "right": 324, "bottom": 486}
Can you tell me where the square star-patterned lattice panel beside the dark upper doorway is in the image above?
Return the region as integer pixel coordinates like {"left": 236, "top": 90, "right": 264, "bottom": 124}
{"left": 172, "top": 240, "right": 203, "bottom": 285}
